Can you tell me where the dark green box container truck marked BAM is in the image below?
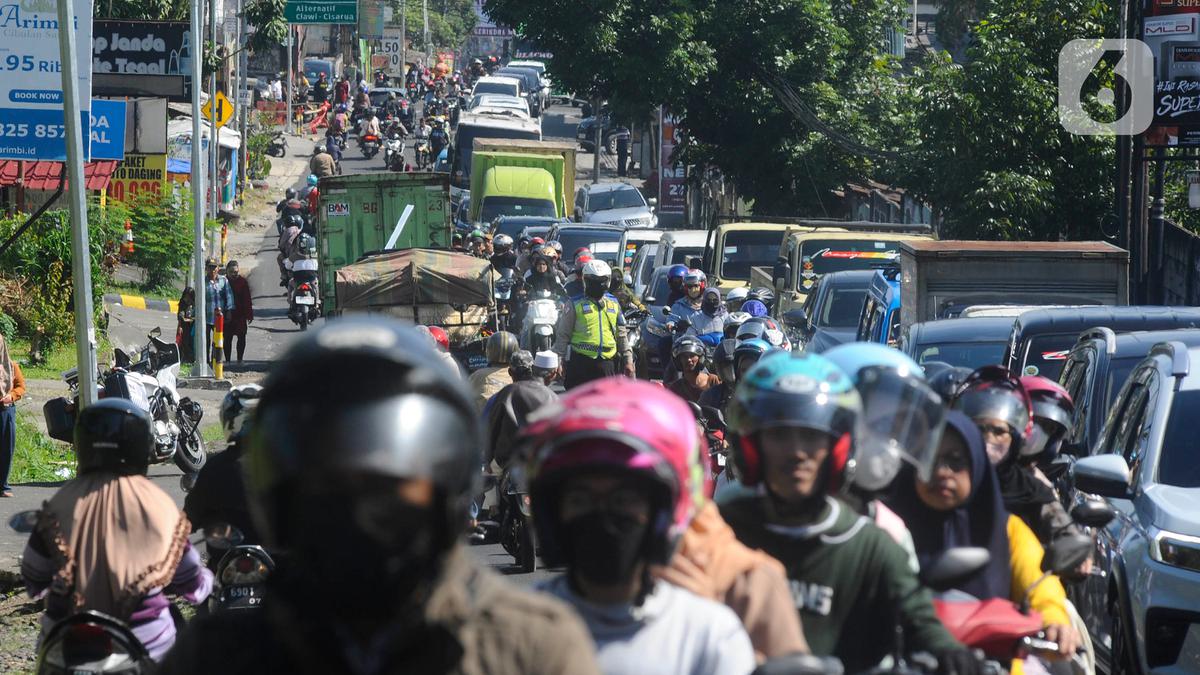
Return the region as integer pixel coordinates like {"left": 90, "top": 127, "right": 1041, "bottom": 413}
{"left": 317, "top": 172, "right": 452, "bottom": 316}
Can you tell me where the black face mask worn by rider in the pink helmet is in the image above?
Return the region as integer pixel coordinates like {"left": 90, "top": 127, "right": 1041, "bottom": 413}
{"left": 563, "top": 512, "right": 649, "bottom": 586}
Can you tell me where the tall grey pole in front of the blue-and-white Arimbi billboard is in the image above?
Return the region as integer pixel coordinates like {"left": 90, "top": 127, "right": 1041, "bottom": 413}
{"left": 58, "top": 0, "right": 96, "bottom": 407}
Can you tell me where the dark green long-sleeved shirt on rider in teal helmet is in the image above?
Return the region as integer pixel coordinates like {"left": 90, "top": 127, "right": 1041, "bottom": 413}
{"left": 721, "top": 496, "right": 961, "bottom": 673}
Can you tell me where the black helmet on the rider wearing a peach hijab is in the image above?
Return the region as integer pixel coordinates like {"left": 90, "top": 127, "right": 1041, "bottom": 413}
{"left": 74, "top": 399, "right": 154, "bottom": 474}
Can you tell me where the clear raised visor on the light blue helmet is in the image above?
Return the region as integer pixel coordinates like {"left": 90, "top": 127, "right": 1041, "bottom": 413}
{"left": 856, "top": 366, "right": 946, "bottom": 488}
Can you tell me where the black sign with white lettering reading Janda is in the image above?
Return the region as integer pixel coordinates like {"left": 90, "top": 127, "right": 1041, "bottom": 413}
{"left": 91, "top": 20, "right": 192, "bottom": 77}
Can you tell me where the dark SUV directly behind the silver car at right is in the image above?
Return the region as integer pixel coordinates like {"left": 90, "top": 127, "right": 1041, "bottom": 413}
{"left": 1058, "top": 327, "right": 1200, "bottom": 456}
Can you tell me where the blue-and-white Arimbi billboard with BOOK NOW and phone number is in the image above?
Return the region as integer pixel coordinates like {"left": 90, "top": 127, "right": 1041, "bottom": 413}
{"left": 0, "top": 0, "right": 91, "bottom": 162}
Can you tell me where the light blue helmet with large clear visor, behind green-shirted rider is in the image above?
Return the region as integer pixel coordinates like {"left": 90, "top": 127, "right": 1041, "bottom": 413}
{"left": 822, "top": 342, "right": 947, "bottom": 492}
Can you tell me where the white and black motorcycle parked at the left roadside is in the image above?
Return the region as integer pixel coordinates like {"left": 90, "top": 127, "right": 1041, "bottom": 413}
{"left": 42, "top": 328, "right": 208, "bottom": 473}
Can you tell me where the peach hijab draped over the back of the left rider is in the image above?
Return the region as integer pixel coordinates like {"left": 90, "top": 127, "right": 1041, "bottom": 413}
{"left": 37, "top": 471, "right": 191, "bottom": 621}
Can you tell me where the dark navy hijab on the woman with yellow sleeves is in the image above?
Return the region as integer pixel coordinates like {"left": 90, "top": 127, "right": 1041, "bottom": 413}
{"left": 884, "top": 411, "right": 1012, "bottom": 599}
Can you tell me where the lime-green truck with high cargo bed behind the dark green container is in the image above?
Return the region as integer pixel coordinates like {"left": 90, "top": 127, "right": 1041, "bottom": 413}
{"left": 470, "top": 138, "right": 575, "bottom": 223}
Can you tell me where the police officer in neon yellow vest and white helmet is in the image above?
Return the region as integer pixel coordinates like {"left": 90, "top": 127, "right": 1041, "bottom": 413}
{"left": 554, "top": 259, "right": 634, "bottom": 389}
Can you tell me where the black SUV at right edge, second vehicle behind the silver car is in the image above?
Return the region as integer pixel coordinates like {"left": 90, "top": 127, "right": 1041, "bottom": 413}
{"left": 1001, "top": 306, "right": 1200, "bottom": 380}
